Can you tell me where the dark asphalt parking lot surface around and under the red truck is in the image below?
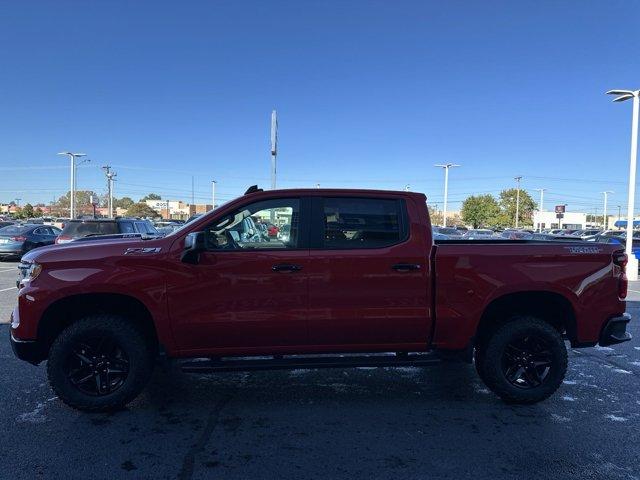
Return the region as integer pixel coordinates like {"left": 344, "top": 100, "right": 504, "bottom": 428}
{"left": 0, "top": 262, "right": 640, "bottom": 480}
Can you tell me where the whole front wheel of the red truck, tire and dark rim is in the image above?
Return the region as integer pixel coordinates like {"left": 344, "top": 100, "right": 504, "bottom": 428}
{"left": 47, "top": 314, "right": 154, "bottom": 412}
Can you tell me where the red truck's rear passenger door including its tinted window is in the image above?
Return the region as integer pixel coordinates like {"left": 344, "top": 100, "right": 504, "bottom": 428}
{"left": 309, "top": 196, "right": 431, "bottom": 350}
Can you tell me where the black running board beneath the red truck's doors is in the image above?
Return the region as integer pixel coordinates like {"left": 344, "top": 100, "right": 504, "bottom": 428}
{"left": 181, "top": 354, "right": 441, "bottom": 373}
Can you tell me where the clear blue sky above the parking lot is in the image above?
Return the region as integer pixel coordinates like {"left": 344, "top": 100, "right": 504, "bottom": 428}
{"left": 0, "top": 0, "right": 640, "bottom": 214}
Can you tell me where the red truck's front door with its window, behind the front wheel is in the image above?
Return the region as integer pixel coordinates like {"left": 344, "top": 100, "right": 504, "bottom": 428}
{"left": 168, "top": 198, "right": 309, "bottom": 354}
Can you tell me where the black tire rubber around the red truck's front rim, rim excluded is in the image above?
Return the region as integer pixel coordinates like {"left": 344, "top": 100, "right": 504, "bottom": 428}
{"left": 47, "top": 314, "right": 155, "bottom": 412}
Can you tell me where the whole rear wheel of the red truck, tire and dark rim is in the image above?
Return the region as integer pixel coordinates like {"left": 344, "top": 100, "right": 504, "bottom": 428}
{"left": 476, "top": 316, "right": 567, "bottom": 404}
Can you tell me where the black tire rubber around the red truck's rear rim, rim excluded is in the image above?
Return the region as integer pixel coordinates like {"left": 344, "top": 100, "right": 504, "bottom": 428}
{"left": 476, "top": 316, "right": 567, "bottom": 404}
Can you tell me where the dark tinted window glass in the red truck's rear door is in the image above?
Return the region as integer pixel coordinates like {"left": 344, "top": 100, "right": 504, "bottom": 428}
{"left": 323, "top": 197, "right": 407, "bottom": 249}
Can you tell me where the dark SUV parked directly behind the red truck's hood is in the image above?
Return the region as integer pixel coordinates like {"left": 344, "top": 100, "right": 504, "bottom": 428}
{"left": 56, "top": 218, "right": 158, "bottom": 243}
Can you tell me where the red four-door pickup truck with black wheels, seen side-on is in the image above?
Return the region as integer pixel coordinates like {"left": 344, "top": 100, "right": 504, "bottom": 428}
{"left": 11, "top": 187, "right": 631, "bottom": 411}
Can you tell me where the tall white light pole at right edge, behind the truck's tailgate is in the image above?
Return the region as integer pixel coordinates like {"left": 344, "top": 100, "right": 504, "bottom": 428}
{"left": 607, "top": 90, "right": 640, "bottom": 280}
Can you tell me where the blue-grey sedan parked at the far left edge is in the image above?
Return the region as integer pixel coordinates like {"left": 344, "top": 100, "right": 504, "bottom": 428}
{"left": 0, "top": 223, "right": 60, "bottom": 260}
